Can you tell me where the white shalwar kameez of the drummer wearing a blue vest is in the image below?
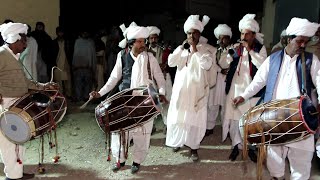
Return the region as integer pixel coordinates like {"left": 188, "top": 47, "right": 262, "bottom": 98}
{"left": 240, "top": 53, "right": 320, "bottom": 180}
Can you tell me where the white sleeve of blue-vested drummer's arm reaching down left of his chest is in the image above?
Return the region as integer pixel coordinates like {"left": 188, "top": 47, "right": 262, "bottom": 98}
{"left": 241, "top": 57, "right": 270, "bottom": 100}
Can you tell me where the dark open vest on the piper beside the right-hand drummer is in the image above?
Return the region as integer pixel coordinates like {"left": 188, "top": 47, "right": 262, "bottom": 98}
{"left": 225, "top": 41, "right": 265, "bottom": 97}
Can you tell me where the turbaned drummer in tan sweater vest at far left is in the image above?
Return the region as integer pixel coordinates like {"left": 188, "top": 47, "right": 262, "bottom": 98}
{"left": 0, "top": 22, "right": 56, "bottom": 180}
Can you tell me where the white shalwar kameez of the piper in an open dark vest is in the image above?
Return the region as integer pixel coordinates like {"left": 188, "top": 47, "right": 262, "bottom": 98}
{"left": 222, "top": 46, "right": 267, "bottom": 149}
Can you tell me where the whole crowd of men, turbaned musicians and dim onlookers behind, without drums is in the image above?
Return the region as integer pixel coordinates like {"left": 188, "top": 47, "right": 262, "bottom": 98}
{"left": 0, "top": 14, "right": 320, "bottom": 179}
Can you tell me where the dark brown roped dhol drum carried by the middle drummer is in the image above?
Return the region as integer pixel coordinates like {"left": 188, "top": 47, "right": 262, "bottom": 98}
{"left": 95, "top": 86, "right": 161, "bottom": 133}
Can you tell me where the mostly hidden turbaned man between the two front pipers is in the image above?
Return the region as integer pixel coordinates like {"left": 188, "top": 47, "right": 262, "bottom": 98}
{"left": 206, "top": 24, "right": 233, "bottom": 136}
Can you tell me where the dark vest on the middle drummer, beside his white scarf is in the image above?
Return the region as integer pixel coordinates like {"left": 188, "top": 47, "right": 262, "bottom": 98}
{"left": 119, "top": 50, "right": 134, "bottom": 91}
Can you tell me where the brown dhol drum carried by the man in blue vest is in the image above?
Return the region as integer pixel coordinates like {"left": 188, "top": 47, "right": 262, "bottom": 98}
{"left": 239, "top": 96, "right": 318, "bottom": 145}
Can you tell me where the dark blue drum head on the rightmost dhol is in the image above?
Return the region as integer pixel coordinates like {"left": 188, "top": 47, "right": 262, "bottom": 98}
{"left": 300, "top": 96, "right": 318, "bottom": 131}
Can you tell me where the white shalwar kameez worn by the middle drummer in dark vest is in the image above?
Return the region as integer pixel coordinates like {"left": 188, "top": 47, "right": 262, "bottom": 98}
{"left": 99, "top": 52, "right": 165, "bottom": 164}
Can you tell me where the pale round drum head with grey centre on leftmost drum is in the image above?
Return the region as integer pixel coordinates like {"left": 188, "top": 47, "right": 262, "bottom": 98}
{"left": 0, "top": 111, "right": 31, "bottom": 144}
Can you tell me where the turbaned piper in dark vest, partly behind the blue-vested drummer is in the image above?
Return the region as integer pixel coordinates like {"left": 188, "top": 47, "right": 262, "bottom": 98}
{"left": 222, "top": 14, "right": 267, "bottom": 162}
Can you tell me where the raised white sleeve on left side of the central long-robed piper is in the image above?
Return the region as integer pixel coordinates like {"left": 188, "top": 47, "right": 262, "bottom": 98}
{"left": 168, "top": 45, "right": 189, "bottom": 67}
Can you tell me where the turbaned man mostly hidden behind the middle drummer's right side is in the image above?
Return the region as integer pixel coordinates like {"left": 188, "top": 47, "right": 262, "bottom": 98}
{"left": 147, "top": 26, "right": 172, "bottom": 132}
